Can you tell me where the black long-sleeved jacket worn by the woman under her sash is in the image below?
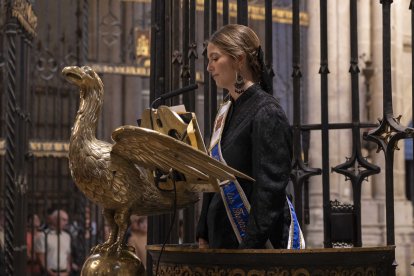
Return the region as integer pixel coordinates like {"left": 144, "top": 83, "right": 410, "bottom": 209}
{"left": 197, "top": 84, "right": 292, "bottom": 248}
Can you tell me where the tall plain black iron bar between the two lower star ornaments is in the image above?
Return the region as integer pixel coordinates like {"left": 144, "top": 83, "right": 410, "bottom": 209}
{"left": 319, "top": 0, "right": 332, "bottom": 248}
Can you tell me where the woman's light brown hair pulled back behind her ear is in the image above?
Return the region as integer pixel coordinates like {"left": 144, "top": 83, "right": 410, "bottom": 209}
{"left": 208, "top": 24, "right": 261, "bottom": 81}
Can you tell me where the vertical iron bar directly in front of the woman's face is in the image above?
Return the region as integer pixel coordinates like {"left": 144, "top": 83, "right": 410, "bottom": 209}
{"left": 203, "top": 0, "right": 211, "bottom": 138}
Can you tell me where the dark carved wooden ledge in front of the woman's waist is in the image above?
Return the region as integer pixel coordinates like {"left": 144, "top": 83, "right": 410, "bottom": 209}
{"left": 147, "top": 245, "right": 395, "bottom": 275}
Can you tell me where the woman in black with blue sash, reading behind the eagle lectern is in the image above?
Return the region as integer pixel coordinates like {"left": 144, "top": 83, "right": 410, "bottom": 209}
{"left": 197, "top": 24, "right": 304, "bottom": 248}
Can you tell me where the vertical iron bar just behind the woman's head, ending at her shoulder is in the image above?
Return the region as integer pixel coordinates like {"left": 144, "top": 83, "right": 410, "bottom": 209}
{"left": 265, "top": 1, "right": 274, "bottom": 94}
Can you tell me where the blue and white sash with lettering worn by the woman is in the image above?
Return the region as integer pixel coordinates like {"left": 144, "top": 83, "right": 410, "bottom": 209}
{"left": 210, "top": 101, "right": 305, "bottom": 249}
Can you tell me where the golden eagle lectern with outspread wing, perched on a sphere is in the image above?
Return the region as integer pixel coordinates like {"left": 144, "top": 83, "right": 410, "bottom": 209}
{"left": 62, "top": 66, "right": 249, "bottom": 275}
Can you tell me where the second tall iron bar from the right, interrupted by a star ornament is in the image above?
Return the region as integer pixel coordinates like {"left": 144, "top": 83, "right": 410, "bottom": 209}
{"left": 349, "top": 0, "right": 363, "bottom": 247}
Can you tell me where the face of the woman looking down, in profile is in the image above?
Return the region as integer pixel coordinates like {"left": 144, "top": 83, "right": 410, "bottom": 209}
{"left": 207, "top": 43, "right": 237, "bottom": 90}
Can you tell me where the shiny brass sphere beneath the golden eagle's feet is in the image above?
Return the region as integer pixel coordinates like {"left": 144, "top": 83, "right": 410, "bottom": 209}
{"left": 81, "top": 250, "right": 145, "bottom": 276}
